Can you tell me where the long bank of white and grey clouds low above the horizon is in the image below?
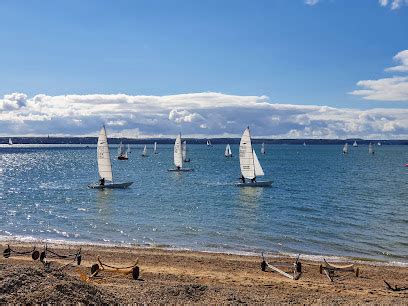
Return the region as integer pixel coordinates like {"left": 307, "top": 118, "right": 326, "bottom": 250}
{"left": 0, "top": 92, "right": 408, "bottom": 139}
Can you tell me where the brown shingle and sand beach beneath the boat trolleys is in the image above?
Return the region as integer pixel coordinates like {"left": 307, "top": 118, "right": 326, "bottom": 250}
{"left": 0, "top": 243, "right": 408, "bottom": 305}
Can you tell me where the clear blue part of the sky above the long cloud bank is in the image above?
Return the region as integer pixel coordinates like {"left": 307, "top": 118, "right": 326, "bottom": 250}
{"left": 0, "top": 0, "right": 408, "bottom": 137}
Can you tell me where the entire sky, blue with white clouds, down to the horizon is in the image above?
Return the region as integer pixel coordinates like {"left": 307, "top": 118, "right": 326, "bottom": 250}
{"left": 0, "top": 0, "right": 408, "bottom": 139}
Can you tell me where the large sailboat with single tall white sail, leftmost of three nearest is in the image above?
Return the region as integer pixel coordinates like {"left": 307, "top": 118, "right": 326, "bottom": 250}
{"left": 88, "top": 126, "right": 133, "bottom": 189}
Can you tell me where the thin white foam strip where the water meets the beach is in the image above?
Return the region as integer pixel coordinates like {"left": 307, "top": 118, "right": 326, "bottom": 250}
{"left": 0, "top": 235, "right": 408, "bottom": 267}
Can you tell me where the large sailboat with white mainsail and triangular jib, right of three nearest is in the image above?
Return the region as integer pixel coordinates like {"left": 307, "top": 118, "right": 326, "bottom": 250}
{"left": 236, "top": 127, "right": 272, "bottom": 187}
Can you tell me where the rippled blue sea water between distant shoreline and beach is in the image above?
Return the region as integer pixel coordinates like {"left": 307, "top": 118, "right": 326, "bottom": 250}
{"left": 0, "top": 145, "right": 408, "bottom": 263}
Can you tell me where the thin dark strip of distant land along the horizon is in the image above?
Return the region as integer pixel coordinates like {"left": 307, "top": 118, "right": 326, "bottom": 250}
{"left": 0, "top": 137, "right": 408, "bottom": 145}
